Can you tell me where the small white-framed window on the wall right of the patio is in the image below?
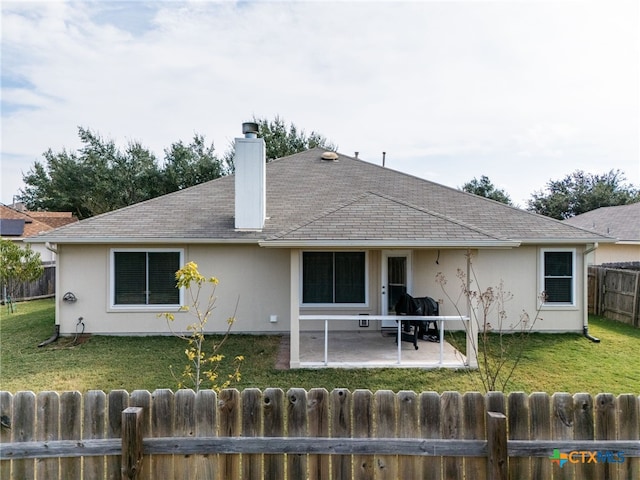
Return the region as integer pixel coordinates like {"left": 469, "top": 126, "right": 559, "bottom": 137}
{"left": 540, "top": 248, "right": 576, "bottom": 306}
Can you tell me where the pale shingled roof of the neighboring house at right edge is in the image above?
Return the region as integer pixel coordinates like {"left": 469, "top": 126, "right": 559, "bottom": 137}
{"left": 565, "top": 202, "right": 640, "bottom": 242}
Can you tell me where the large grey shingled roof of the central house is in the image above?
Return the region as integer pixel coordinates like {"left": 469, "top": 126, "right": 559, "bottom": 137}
{"left": 31, "top": 148, "right": 613, "bottom": 247}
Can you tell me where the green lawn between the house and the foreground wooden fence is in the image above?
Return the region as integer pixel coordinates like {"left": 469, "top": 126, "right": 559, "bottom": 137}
{"left": 0, "top": 300, "right": 640, "bottom": 395}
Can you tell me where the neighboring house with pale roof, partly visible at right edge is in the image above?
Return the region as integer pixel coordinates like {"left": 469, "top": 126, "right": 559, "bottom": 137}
{"left": 565, "top": 202, "right": 640, "bottom": 265}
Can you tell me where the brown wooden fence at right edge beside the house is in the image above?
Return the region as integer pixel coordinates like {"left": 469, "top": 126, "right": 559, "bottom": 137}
{"left": 588, "top": 266, "right": 640, "bottom": 328}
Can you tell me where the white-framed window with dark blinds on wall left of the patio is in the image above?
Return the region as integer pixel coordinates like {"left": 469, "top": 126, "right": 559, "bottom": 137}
{"left": 111, "top": 250, "right": 182, "bottom": 306}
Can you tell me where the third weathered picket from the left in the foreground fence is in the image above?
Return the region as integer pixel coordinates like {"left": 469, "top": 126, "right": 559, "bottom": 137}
{"left": 36, "top": 392, "right": 60, "bottom": 480}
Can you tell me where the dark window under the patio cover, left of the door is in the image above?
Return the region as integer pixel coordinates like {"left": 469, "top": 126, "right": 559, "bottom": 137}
{"left": 302, "top": 252, "right": 366, "bottom": 304}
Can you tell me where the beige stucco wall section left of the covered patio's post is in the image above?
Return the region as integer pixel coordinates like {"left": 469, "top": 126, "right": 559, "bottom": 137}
{"left": 56, "top": 245, "right": 289, "bottom": 334}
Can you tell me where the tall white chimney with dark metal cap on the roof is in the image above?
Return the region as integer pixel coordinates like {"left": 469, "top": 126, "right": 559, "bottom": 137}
{"left": 233, "top": 122, "right": 267, "bottom": 230}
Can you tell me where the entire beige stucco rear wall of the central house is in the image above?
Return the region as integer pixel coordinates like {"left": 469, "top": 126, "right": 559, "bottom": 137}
{"left": 56, "top": 245, "right": 584, "bottom": 335}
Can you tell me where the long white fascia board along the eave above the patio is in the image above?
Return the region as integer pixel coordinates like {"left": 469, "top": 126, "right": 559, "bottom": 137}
{"left": 259, "top": 240, "right": 520, "bottom": 248}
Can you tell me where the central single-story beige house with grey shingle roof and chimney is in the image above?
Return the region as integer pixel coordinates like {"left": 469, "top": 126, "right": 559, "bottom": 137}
{"left": 30, "top": 124, "right": 614, "bottom": 368}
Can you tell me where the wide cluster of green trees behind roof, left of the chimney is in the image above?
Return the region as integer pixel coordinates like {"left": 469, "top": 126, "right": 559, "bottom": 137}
{"left": 20, "top": 127, "right": 225, "bottom": 219}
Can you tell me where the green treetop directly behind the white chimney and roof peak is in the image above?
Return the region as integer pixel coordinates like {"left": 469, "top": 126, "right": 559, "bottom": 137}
{"left": 225, "top": 115, "right": 337, "bottom": 171}
